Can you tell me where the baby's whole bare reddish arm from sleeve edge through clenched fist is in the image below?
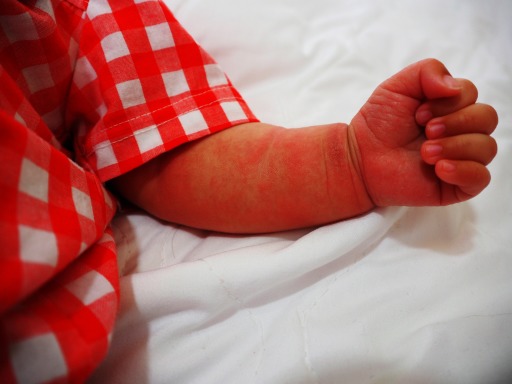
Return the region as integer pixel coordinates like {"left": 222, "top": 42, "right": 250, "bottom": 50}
{"left": 112, "top": 60, "right": 497, "bottom": 233}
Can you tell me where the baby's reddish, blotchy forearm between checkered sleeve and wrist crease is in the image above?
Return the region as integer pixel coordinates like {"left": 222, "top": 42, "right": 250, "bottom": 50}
{"left": 112, "top": 123, "right": 373, "bottom": 233}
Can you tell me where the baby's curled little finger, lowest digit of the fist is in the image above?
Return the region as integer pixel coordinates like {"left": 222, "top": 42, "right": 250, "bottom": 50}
{"left": 435, "top": 160, "right": 491, "bottom": 204}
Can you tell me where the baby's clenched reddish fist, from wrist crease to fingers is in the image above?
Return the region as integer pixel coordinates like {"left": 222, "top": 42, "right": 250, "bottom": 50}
{"left": 349, "top": 59, "right": 498, "bottom": 206}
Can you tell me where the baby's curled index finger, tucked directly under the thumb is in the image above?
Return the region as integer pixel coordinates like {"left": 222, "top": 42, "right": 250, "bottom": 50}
{"left": 416, "top": 79, "right": 478, "bottom": 126}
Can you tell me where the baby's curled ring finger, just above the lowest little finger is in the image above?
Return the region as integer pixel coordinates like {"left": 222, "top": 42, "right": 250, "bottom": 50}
{"left": 421, "top": 133, "right": 498, "bottom": 165}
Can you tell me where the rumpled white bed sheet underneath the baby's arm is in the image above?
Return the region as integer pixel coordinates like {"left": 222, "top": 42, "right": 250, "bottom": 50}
{"left": 91, "top": 0, "right": 512, "bottom": 384}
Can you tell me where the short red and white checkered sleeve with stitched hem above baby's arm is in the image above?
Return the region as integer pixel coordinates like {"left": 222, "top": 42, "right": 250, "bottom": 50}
{"left": 68, "top": 0, "right": 257, "bottom": 181}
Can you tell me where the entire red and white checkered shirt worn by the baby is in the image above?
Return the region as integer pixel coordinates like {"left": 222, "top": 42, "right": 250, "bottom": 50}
{"left": 0, "top": 0, "right": 256, "bottom": 383}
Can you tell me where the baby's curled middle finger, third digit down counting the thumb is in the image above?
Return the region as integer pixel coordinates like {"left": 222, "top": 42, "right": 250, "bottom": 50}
{"left": 425, "top": 104, "right": 498, "bottom": 139}
